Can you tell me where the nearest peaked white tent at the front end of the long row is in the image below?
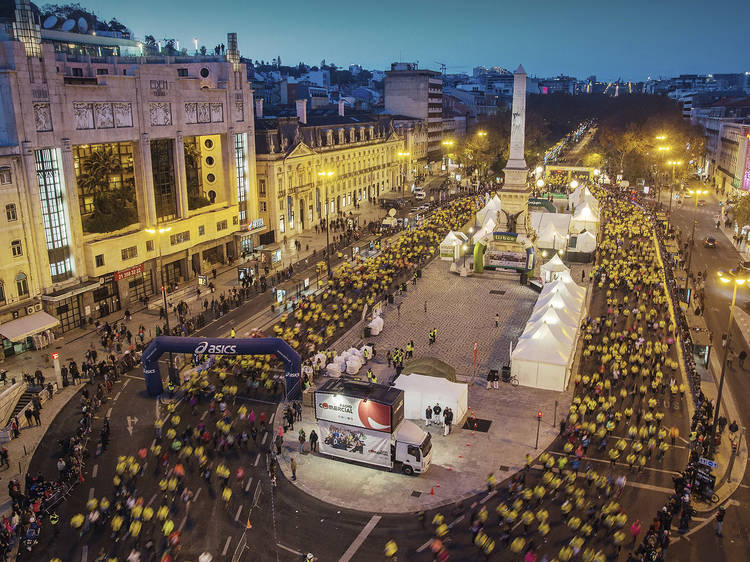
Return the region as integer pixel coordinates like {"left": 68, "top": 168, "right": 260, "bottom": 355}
{"left": 510, "top": 328, "right": 571, "bottom": 392}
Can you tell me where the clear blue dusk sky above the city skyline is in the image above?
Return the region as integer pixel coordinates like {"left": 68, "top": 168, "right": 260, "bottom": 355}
{"left": 73, "top": 0, "right": 750, "bottom": 80}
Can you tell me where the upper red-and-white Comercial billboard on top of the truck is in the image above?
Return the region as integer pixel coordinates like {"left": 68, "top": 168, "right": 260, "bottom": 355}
{"left": 315, "top": 392, "right": 404, "bottom": 433}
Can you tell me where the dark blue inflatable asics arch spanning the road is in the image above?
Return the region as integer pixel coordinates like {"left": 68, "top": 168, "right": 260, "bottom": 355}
{"left": 141, "top": 336, "right": 302, "bottom": 400}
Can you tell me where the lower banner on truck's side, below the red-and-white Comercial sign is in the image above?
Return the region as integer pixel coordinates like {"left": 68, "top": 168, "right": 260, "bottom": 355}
{"left": 318, "top": 418, "right": 391, "bottom": 467}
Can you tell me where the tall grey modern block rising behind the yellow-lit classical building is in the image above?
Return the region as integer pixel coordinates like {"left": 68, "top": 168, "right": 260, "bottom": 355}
{"left": 384, "top": 63, "right": 443, "bottom": 162}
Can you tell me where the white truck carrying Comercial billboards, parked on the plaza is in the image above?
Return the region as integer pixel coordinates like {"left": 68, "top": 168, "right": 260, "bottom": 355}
{"left": 315, "top": 378, "right": 432, "bottom": 475}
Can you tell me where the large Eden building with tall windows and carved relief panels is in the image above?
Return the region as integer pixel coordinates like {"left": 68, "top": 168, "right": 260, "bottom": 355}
{"left": 0, "top": 29, "right": 260, "bottom": 334}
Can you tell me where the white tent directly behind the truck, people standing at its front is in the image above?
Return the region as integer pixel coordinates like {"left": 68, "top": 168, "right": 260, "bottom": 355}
{"left": 394, "top": 374, "right": 469, "bottom": 424}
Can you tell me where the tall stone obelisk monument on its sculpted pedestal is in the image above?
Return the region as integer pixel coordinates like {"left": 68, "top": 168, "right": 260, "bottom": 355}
{"left": 498, "top": 65, "right": 533, "bottom": 237}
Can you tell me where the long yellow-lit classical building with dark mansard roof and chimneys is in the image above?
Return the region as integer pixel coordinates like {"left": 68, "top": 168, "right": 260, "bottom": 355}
{"left": 255, "top": 104, "right": 409, "bottom": 244}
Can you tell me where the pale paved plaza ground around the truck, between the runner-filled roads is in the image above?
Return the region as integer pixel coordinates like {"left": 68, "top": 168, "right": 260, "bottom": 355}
{"left": 276, "top": 261, "right": 572, "bottom": 512}
